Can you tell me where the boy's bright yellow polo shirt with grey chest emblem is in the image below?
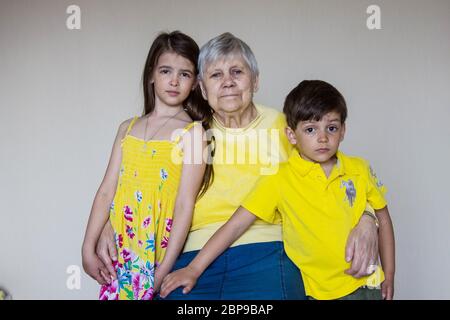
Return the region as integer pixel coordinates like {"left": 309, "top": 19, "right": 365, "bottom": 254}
{"left": 242, "top": 150, "right": 386, "bottom": 299}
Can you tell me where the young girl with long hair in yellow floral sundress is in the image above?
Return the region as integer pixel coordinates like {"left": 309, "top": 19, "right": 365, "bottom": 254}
{"left": 82, "top": 31, "right": 212, "bottom": 299}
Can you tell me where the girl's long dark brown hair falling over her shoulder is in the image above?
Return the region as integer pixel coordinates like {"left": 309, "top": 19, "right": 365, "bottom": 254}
{"left": 142, "top": 31, "right": 214, "bottom": 198}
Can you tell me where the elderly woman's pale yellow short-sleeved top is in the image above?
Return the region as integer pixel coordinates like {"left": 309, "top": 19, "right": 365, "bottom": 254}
{"left": 183, "top": 104, "right": 292, "bottom": 252}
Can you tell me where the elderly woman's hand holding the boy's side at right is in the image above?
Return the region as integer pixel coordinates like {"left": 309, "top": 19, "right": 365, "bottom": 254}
{"left": 345, "top": 215, "right": 379, "bottom": 278}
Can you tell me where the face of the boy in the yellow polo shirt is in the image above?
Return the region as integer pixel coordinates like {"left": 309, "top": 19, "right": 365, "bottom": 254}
{"left": 286, "top": 111, "right": 345, "bottom": 164}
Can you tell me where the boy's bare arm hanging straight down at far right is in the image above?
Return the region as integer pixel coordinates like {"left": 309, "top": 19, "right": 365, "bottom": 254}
{"left": 375, "top": 206, "right": 395, "bottom": 300}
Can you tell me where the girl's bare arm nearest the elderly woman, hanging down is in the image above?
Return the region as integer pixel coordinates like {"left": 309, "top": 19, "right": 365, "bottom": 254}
{"left": 155, "top": 125, "right": 206, "bottom": 291}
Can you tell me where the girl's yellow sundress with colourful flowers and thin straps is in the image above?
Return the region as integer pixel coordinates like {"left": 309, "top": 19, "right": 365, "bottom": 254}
{"left": 99, "top": 117, "right": 196, "bottom": 300}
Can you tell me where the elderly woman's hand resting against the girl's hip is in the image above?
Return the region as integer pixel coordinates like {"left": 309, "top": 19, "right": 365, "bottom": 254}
{"left": 96, "top": 220, "right": 117, "bottom": 279}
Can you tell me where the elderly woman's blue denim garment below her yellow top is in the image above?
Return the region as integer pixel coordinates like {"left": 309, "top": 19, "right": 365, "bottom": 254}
{"left": 161, "top": 241, "right": 306, "bottom": 300}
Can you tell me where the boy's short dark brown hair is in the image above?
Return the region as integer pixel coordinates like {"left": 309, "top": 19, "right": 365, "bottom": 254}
{"left": 283, "top": 80, "right": 347, "bottom": 130}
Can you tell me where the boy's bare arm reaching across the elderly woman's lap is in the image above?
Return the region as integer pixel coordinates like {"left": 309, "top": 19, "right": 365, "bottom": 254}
{"left": 160, "top": 207, "right": 256, "bottom": 298}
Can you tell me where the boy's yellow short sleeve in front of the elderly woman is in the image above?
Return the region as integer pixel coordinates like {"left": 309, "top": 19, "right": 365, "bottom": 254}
{"left": 241, "top": 175, "right": 279, "bottom": 223}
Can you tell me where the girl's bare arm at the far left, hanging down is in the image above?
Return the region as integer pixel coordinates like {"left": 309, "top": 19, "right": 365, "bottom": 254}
{"left": 82, "top": 120, "right": 130, "bottom": 284}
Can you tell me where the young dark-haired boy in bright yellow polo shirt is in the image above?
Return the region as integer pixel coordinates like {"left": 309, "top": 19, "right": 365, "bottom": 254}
{"left": 161, "top": 80, "right": 395, "bottom": 300}
